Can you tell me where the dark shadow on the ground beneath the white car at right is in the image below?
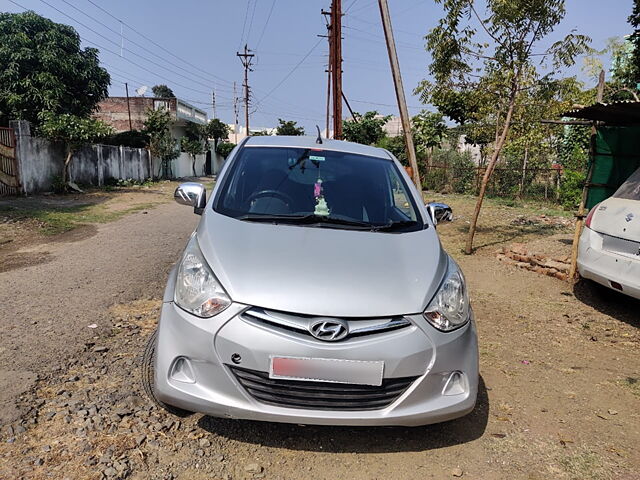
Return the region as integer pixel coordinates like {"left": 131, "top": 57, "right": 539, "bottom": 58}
{"left": 573, "top": 279, "right": 640, "bottom": 328}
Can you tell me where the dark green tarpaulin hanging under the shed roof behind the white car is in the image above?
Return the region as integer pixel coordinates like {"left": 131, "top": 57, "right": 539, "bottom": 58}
{"left": 585, "top": 126, "right": 640, "bottom": 211}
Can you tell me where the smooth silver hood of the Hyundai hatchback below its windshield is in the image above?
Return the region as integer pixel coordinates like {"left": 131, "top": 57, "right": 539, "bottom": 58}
{"left": 197, "top": 210, "right": 448, "bottom": 317}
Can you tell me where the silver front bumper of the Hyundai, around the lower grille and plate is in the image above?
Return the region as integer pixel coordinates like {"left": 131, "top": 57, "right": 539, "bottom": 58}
{"left": 155, "top": 301, "right": 478, "bottom": 426}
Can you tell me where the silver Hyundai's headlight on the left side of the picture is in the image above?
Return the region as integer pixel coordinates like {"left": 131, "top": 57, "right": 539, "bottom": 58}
{"left": 174, "top": 236, "right": 231, "bottom": 317}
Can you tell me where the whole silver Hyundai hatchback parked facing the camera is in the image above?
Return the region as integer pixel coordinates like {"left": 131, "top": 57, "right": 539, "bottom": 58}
{"left": 143, "top": 136, "right": 478, "bottom": 426}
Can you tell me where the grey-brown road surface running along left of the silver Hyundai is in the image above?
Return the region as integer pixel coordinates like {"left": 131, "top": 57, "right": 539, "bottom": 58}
{"left": 0, "top": 199, "right": 197, "bottom": 424}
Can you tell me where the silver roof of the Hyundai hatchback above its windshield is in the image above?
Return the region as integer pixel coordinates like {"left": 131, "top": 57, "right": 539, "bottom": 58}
{"left": 245, "top": 135, "right": 390, "bottom": 160}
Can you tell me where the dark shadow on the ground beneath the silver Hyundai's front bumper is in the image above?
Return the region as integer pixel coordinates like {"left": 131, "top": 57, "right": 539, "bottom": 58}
{"left": 198, "top": 377, "right": 489, "bottom": 453}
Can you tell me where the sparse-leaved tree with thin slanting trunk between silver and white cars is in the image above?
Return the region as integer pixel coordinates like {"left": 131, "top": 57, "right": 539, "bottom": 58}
{"left": 418, "top": 0, "right": 590, "bottom": 254}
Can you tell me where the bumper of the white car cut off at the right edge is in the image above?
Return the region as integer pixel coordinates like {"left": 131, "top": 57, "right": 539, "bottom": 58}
{"left": 578, "top": 227, "right": 640, "bottom": 299}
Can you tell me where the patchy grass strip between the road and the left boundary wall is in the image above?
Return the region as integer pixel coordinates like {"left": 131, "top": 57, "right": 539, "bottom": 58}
{"left": 0, "top": 203, "right": 156, "bottom": 235}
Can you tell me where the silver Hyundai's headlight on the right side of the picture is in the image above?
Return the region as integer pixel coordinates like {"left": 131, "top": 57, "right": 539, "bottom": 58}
{"left": 423, "top": 260, "right": 470, "bottom": 332}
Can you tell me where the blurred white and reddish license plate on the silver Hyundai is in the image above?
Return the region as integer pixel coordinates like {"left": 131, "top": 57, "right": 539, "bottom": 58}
{"left": 269, "top": 357, "right": 384, "bottom": 386}
